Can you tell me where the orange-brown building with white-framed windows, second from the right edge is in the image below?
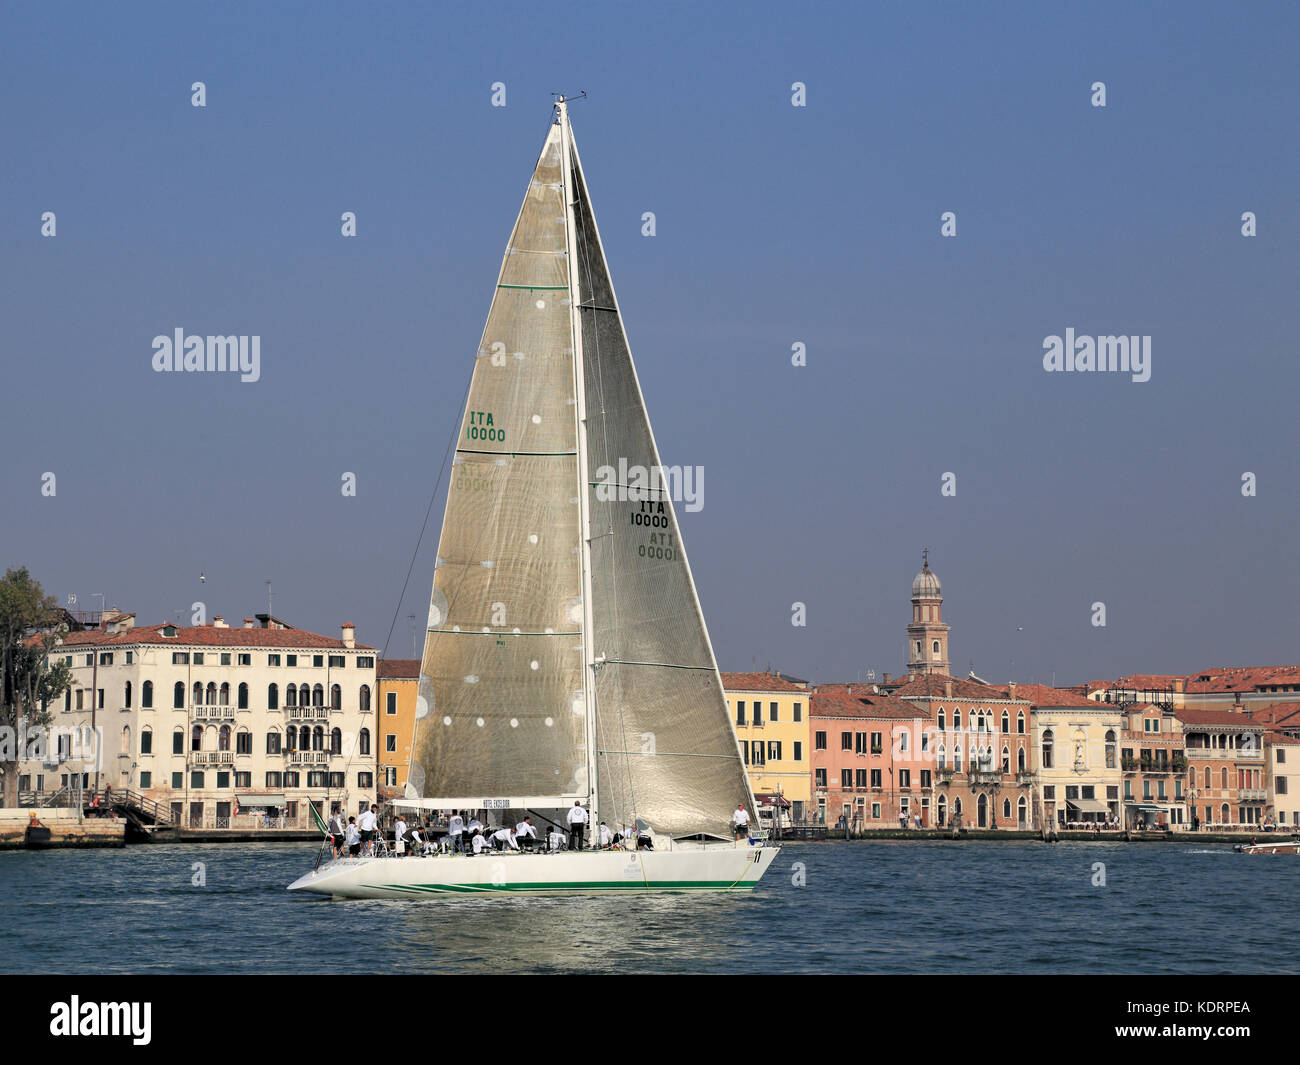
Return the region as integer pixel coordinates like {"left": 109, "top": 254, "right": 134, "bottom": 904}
{"left": 1177, "top": 709, "right": 1268, "bottom": 830}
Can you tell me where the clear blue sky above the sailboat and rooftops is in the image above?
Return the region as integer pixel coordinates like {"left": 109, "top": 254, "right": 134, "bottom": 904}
{"left": 0, "top": 3, "right": 1300, "bottom": 683}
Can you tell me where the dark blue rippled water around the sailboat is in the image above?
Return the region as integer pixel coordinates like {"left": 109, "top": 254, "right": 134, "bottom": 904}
{"left": 0, "top": 841, "right": 1300, "bottom": 974}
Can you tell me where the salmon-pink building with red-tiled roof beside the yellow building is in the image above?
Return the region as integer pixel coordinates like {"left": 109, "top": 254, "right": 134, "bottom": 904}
{"left": 811, "top": 684, "right": 935, "bottom": 831}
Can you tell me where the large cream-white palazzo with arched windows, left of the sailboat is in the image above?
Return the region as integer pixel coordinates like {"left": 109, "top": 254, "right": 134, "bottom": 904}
{"left": 18, "top": 611, "right": 376, "bottom": 828}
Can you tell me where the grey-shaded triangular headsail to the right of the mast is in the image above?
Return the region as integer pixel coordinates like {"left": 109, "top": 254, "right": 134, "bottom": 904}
{"left": 566, "top": 116, "right": 755, "bottom": 835}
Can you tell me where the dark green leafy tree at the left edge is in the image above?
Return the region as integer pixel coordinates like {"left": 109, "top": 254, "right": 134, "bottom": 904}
{"left": 0, "top": 568, "right": 72, "bottom": 806}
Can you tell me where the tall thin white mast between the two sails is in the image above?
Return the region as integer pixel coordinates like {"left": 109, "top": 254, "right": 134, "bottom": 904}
{"left": 555, "top": 96, "right": 601, "bottom": 834}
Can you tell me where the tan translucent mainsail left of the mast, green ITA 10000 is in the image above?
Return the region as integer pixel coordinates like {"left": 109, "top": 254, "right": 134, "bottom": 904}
{"left": 411, "top": 118, "right": 588, "bottom": 805}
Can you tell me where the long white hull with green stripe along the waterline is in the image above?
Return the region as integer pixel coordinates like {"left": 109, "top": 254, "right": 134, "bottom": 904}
{"left": 289, "top": 844, "right": 780, "bottom": 899}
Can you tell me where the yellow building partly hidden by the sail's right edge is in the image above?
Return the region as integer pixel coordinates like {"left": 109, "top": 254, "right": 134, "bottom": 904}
{"left": 723, "top": 672, "right": 813, "bottom": 823}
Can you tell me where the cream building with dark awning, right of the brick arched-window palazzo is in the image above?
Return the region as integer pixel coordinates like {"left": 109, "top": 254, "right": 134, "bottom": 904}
{"left": 1015, "top": 684, "right": 1125, "bottom": 828}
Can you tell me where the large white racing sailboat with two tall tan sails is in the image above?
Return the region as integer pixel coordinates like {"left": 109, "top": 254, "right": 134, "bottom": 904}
{"left": 290, "top": 96, "right": 779, "bottom": 899}
